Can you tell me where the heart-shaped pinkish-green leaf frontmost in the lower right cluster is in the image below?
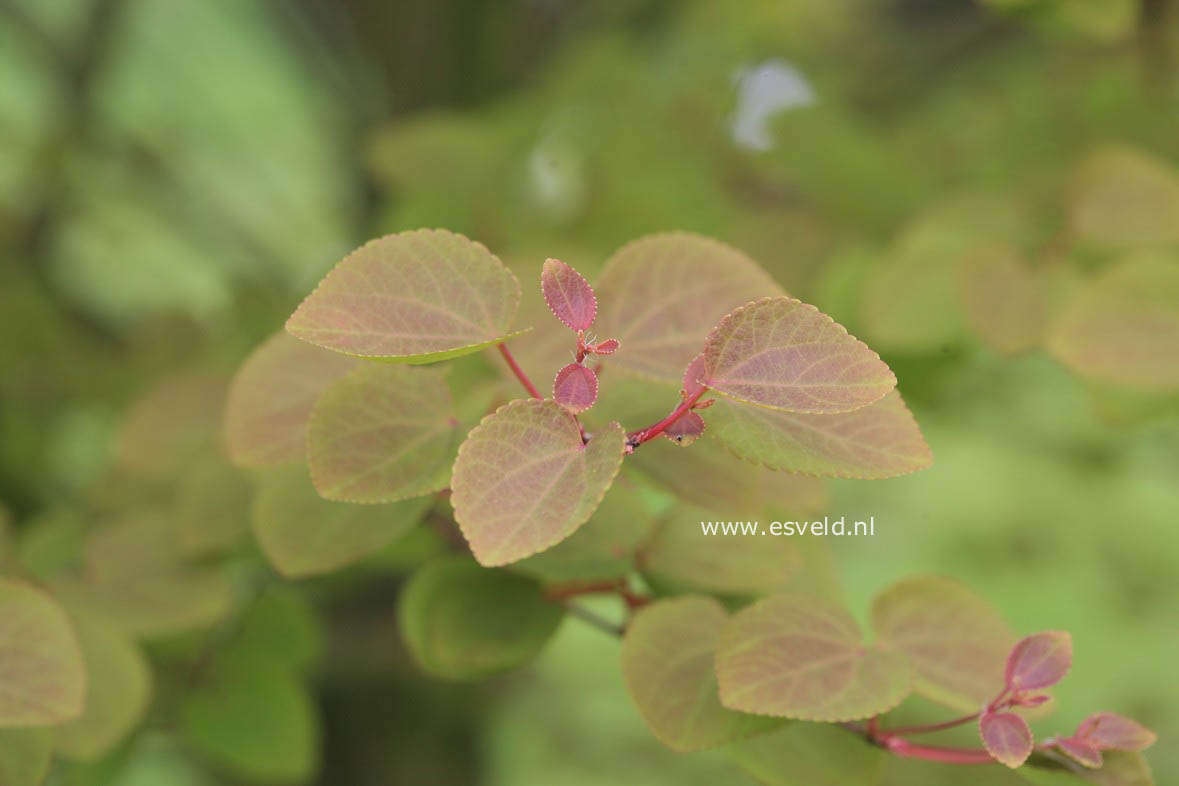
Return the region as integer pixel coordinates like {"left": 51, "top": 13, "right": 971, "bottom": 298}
{"left": 717, "top": 594, "right": 913, "bottom": 722}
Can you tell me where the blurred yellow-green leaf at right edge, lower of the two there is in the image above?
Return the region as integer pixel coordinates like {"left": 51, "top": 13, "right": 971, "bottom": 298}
{"left": 1047, "top": 257, "right": 1179, "bottom": 391}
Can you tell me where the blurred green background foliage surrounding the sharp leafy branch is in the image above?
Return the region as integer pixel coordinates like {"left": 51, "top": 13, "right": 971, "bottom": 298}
{"left": 0, "top": 0, "right": 1179, "bottom": 786}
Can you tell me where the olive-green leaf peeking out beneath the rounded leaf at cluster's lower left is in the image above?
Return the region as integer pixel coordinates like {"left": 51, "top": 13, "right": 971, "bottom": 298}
{"left": 252, "top": 465, "right": 432, "bottom": 577}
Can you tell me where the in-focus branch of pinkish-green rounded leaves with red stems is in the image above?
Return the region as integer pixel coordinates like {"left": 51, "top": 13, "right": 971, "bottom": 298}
{"left": 214, "top": 230, "right": 1153, "bottom": 786}
